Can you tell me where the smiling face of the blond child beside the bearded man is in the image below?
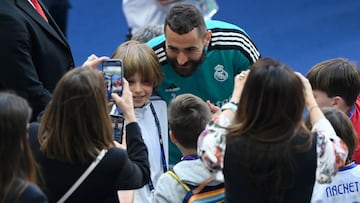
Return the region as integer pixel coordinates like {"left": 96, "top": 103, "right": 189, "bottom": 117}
{"left": 127, "top": 73, "right": 153, "bottom": 108}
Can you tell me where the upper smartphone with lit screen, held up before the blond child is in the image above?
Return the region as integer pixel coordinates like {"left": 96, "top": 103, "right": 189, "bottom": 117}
{"left": 101, "top": 59, "right": 124, "bottom": 101}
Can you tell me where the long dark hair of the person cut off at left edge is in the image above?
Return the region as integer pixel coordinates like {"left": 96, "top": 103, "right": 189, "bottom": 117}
{"left": 0, "top": 92, "right": 36, "bottom": 202}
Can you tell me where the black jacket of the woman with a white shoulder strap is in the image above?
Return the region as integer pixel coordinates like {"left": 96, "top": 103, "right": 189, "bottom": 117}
{"left": 29, "top": 122, "right": 150, "bottom": 203}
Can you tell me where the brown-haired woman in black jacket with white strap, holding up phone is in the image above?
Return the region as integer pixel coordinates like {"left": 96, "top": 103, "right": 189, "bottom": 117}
{"left": 29, "top": 67, "right": 150, "bottom": 202}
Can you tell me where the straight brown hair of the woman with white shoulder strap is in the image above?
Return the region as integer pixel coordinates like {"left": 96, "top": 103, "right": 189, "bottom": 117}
{"left": 38, "top": 67, "right": 114, "bottom": 163}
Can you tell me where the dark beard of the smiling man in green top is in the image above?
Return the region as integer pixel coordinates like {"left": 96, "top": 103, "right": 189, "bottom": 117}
{"left": 167, "top": 49, "right": 206, "bottom": 77}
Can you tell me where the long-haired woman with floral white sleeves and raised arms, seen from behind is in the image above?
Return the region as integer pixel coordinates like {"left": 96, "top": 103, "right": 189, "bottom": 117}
{"left": 198, "top": 58, "right": 347, "bottom": 203}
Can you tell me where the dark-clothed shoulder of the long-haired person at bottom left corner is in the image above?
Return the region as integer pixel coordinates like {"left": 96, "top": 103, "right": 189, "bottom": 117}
{"left": 19, "top": 183, "right": 48, "bottom": 203}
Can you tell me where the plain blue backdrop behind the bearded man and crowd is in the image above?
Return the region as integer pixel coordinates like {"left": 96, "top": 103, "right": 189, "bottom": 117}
{"left": 67, "top": 0, "right": 360, "bottom": 73}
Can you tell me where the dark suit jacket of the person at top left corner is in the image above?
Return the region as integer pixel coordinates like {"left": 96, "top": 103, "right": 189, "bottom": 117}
{"left": 0, "top": 0, "right": 74, "bottom": 120}
